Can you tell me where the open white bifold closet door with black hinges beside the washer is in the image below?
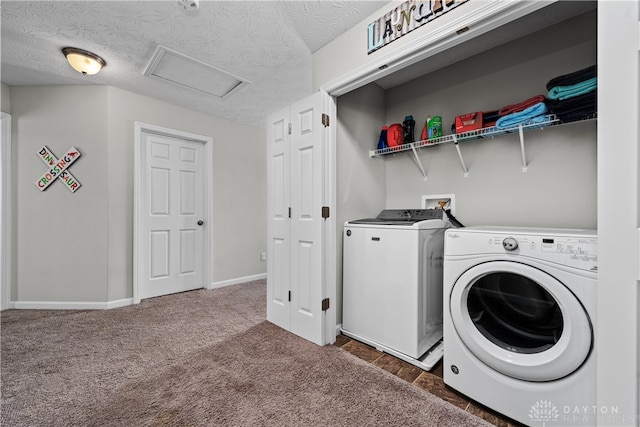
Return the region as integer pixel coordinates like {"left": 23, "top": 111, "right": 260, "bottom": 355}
{"left": 267, "top": 92, "right": 335, "bottom": 345}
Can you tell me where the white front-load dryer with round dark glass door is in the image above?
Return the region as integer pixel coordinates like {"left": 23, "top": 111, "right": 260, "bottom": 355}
{"left": 443, "top": 227, "right": 603, "bottom": 426}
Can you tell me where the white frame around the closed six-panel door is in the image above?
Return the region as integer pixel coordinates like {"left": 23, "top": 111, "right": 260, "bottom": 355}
{"left": 133, "top": 122, "right": 213, "bottom": 304}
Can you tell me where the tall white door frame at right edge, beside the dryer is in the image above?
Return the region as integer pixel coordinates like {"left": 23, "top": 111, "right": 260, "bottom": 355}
{"left": 596, "top": 0, "right": 640, "bottom": 426}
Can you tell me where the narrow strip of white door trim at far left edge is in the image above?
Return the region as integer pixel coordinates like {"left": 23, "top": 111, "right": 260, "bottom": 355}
{"left": 0, "top": 113, "right": 12, "bottom": 310}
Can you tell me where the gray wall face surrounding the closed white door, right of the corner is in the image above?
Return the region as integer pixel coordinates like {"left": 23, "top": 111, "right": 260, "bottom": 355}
{"left": 109, "top": 88, "right": 267, "bottom": 300}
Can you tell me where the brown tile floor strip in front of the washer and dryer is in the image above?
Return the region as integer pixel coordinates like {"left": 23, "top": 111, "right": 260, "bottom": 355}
{"left": 334, "top": 335, "right": 521, "bottom": 427}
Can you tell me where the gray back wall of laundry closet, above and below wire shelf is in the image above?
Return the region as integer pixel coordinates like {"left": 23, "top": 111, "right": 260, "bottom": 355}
{"left": 385, "top": 13, "right": 597, "bottom": 228}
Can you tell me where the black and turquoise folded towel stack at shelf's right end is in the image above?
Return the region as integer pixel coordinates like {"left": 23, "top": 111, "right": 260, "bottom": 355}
{"left": 547, "top": 65, "right": 598, "bottom": 122}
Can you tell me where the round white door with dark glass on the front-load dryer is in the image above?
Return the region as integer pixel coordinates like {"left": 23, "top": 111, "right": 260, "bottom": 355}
{"left": 449, "top": 261, "right": 593, "bottom": 381}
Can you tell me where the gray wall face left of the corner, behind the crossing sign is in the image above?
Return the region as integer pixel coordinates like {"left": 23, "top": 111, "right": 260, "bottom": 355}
{"left": 11, "top": 86, "right": 109, "bottom": 301}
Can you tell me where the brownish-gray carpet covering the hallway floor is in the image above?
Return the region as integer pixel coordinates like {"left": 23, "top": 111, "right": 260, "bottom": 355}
{"left": 0, "top": 281, "right": 488, "bottom": 426}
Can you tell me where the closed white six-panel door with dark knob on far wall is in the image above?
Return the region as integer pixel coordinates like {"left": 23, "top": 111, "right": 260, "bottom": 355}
{"left": 137, "top": 130, "right": 207, "bottom": 299}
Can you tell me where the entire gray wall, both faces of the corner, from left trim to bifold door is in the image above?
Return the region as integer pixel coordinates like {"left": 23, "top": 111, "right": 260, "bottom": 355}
{"left": 11, "top": 86, "right": 266, "bottom": 302}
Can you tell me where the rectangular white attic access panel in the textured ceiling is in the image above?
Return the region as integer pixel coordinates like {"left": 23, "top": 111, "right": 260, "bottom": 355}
{"left": 143, "top": 45, "right": 251, "bottom": 99}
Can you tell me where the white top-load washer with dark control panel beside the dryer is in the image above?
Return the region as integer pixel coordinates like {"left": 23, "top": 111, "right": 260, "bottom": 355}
{"left": 342, "top": 209, "right": 450, "bottom": 370}
